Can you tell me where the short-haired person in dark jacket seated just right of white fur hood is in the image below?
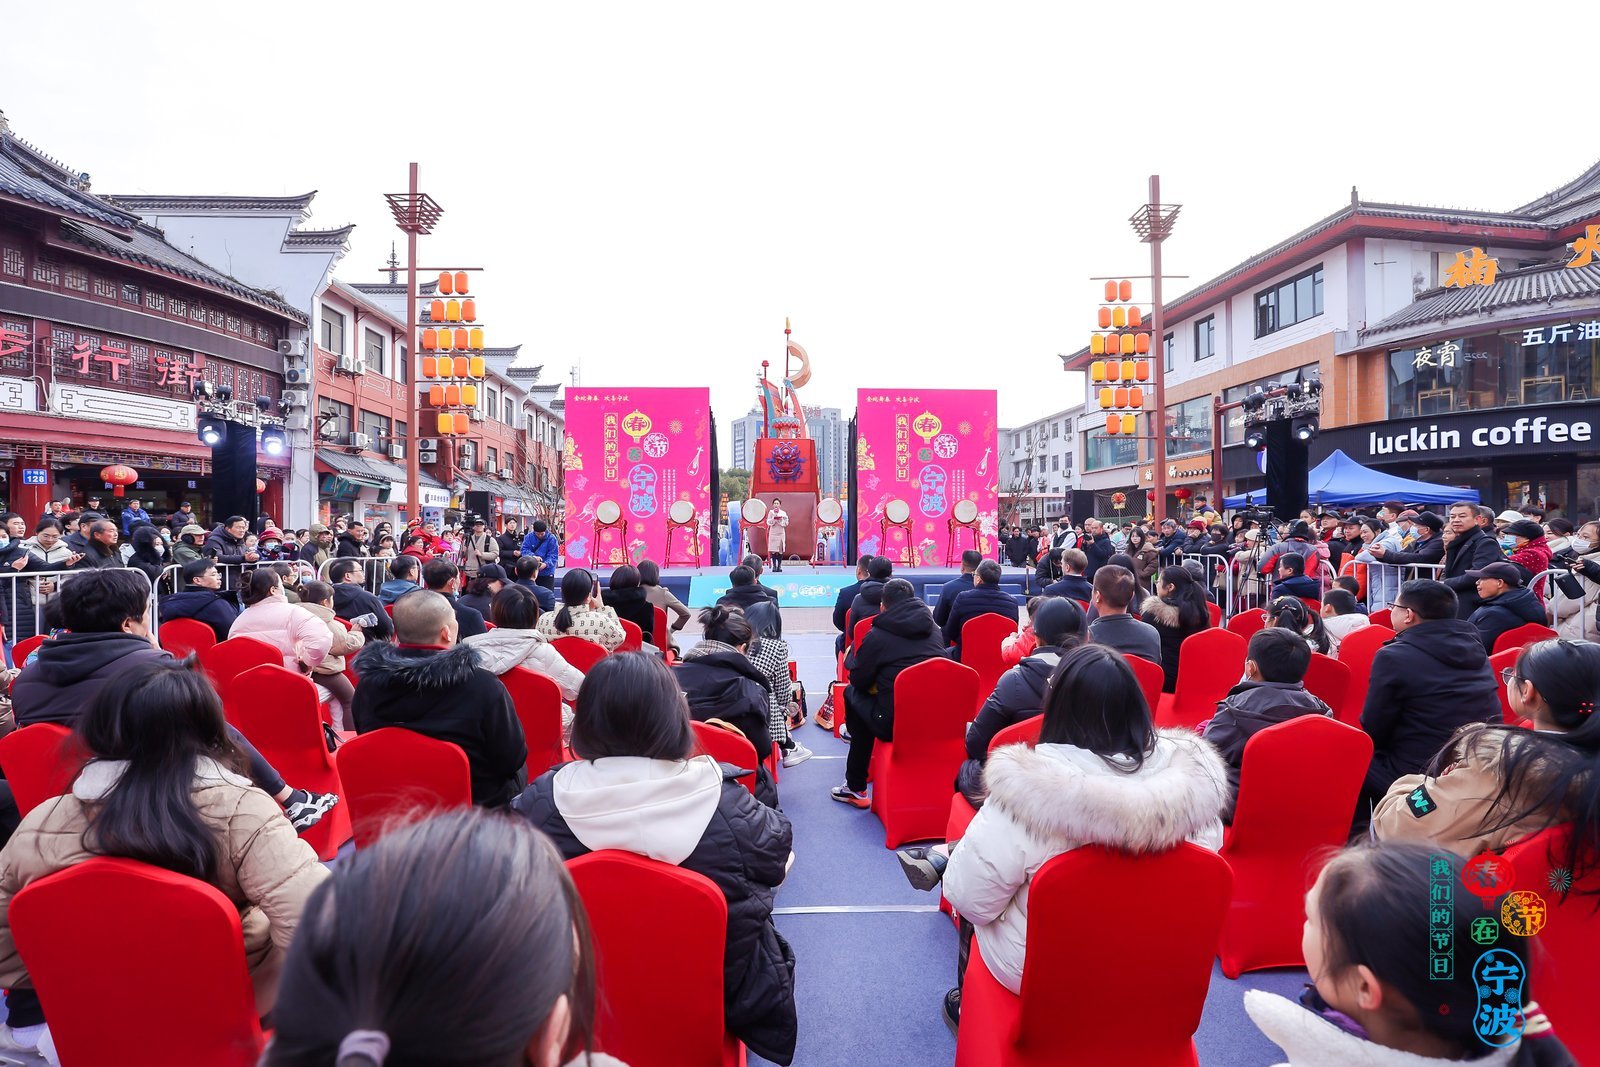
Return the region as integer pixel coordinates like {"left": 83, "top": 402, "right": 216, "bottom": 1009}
{"left": 1200, "top": 625, "right": 1333, "bottom": 822}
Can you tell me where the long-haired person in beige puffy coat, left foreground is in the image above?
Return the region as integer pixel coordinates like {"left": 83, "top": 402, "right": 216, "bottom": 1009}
{"left": 0, "top": 659, "right": 328, "bottom": 1048}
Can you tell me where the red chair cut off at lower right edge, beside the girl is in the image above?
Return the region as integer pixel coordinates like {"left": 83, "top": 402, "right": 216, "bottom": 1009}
{"left": 1502, "top": 822, "right": 1600, "bottom": 1064}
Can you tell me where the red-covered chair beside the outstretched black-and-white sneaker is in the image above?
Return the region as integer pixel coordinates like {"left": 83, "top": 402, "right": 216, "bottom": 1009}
{"left": 218, "top": 662, "right": 350, "bottom": 859}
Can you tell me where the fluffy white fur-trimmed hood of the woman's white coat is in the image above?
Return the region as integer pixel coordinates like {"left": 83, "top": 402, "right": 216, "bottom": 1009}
{"left": 984, "top": 729, "right": 1229, "bottom": 853}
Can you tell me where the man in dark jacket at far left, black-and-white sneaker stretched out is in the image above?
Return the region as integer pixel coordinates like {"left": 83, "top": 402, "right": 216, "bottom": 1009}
{"left": 11, "top": 568, "right": 339, "bottom": 833}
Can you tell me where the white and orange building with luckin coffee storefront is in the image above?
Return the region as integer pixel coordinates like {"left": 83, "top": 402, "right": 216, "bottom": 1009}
{"left": 1064, "top": 163, "right": 1600, "bottom": 517}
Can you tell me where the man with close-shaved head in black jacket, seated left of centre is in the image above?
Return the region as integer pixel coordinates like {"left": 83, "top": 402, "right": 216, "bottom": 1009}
{"left": 350, "top": 592, "right": 528, "bottom": 808}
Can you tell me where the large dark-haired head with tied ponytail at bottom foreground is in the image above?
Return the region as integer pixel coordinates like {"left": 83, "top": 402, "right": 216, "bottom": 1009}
{"left": 261, "top": 809, "right": 621, "bottom": 1067}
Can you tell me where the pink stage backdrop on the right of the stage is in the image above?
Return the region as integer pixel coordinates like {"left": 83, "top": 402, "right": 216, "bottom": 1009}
{"left": 856, "top": 389, "right": 1000, "bottom": 566}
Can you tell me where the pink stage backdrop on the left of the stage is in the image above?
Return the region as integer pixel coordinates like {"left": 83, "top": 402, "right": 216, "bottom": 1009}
{"left": 565, "top": 389, "right": 710, "bottom": 568}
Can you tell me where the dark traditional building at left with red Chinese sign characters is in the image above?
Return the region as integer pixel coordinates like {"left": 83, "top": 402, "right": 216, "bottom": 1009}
{"left": 0, "top": 120, "right": 306, "bottom": 518}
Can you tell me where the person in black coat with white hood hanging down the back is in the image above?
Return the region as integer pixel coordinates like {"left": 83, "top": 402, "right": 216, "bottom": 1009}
{"left": 512, "top": 653, "right": 798, "bottom": 1064}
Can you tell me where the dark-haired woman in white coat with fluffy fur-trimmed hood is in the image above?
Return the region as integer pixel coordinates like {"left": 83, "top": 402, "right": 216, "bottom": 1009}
{"left": 944, "top": 645, "right": 1229, "bottom": 1017}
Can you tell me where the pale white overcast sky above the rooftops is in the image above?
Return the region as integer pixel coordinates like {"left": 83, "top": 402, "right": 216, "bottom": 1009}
{"left": 0, "top": 0, "right": 1600, "bottom": 454}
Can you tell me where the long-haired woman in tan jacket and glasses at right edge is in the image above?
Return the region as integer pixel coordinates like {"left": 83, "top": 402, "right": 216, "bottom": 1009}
{"left": 1373, "top": 638, "right": 1600, "bottom": 880}
